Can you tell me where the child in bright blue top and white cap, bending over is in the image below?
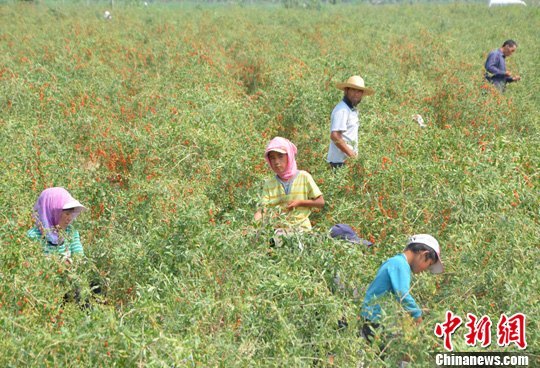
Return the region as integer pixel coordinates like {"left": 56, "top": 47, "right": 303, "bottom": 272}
{"left": 360, "top": 234, "right": 443, "bottom": 343}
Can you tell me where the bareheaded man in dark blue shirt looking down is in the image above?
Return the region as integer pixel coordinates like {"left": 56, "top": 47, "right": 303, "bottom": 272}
{"left": 485, "top": 40, "right": 521, "bottom": 92}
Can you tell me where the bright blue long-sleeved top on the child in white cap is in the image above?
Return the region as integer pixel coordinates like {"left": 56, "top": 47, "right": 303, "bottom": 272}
{"left": 360, "top": 254, "right": 422, "bottom": 322}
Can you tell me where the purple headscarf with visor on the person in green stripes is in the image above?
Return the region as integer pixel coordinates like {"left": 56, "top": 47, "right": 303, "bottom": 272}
{"left": 34, "top": 187, "right": 84, "bottom": 244}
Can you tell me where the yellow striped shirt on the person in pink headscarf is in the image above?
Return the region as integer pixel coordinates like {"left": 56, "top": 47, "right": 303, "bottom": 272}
{"left": 262, "top": 170, "right": 322, "bottom": 230}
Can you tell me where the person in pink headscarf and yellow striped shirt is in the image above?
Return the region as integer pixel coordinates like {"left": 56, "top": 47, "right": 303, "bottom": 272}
{"left": 255, "top": 137, "right": 324, "bottom": 231}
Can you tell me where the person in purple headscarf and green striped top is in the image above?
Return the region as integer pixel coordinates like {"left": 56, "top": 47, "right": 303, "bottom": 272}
{"left": 27, "top": 187, "right": 86, "bottom": 258}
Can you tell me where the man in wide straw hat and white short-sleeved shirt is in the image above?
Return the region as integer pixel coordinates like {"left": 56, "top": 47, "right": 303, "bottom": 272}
{"left": 326, "top": 75, "right": 375, "bottom": 168}
